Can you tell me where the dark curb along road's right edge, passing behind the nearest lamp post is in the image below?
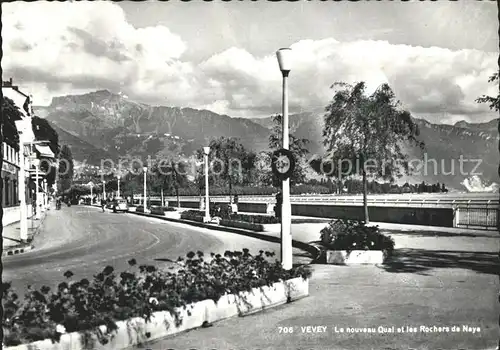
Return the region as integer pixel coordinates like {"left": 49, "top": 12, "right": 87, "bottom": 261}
{"left": 129, "top": 208, "right": 320, "bottom": 261}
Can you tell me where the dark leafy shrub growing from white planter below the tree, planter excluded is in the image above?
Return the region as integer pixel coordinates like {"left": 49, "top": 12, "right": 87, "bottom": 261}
{"left": 320, "top": 219, "right": 394, "bottom": 255}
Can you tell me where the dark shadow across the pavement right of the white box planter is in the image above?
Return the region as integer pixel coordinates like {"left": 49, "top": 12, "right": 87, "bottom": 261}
{"left": 382, "top": 249, "right": 499, "bottom": 275}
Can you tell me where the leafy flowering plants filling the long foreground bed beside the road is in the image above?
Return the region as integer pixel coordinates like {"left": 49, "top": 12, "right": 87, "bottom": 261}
{"left": 2, "top": 249, "right": 311, "bottom": 349}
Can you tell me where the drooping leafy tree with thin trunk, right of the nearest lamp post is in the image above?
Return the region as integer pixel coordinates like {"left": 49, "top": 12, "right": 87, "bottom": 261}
{"left": 323, "top": 82, "right": 424, "bottom": 222}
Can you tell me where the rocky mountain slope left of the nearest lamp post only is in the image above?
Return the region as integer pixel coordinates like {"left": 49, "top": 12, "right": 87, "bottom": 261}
{"left": 39, "top": 90, "right": 269, "bottom": 162}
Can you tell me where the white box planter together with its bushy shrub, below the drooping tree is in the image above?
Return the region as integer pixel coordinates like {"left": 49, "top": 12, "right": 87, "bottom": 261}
{"left": 321, "top": 220, "right": 394, "bottom": 264}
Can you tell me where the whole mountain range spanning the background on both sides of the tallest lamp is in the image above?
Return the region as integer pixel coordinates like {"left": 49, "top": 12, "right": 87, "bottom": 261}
{"left": 34, "top": 90, "right": 499, "bottom": 190}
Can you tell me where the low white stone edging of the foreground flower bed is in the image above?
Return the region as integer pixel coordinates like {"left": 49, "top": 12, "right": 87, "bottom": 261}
{"left": 5, "top": 277, "right": 309, "bottom": 350}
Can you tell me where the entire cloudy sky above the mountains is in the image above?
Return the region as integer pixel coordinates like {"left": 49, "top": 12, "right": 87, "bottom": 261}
{"left": 2, "top": 0, "right": 499, "bottom": 124}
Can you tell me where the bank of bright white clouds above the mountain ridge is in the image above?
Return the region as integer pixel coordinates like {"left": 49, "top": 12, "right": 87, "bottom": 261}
{"left": 2, "top": 2, "right": 498, "bottom": 121}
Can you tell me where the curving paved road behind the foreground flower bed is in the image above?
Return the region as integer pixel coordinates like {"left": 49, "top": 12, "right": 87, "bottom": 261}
{"left": 3, "top": 206, "right": 304, "bottom": 290}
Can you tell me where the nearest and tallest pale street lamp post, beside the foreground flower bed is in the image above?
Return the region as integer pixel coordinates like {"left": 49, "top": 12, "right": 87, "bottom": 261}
{"left": 276, "top": 48, "right": 292, "bottom": 270}
